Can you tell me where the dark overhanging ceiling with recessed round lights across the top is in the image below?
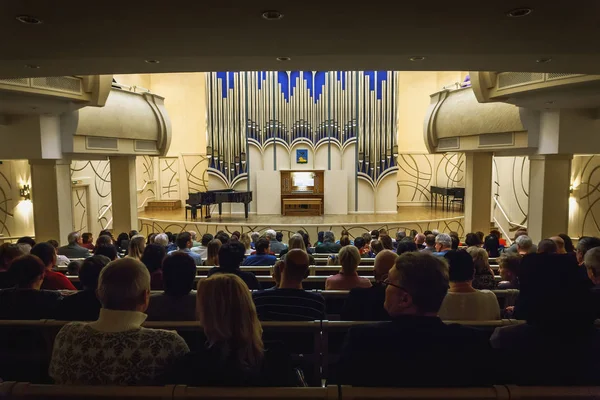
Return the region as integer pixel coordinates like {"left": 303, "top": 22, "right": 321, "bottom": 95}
{"left": 0, "top": 0, "right": 600, "bottom": 78}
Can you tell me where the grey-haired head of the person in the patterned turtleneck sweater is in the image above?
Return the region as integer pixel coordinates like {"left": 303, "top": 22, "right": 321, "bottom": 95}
{"left": 96, "top": 258, "right": 150, "bottom": 312}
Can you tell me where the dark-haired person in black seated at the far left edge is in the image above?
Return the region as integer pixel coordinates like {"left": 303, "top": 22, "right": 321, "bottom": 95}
{"left": 0, "top": 255, "right": 61, "bottom": 320}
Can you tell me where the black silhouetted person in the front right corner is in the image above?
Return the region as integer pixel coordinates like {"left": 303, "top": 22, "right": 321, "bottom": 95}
{"left": 490, "top": 254, "right": 600, "bottom": 386}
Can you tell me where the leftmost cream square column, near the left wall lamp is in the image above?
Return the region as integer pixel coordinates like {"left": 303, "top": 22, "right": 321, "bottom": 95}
{"left": 29, "top": 160, "right": 73, "bottom": 244}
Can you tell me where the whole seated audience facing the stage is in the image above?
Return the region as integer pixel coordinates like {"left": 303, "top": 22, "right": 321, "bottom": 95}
{"left": 0, "top": 230, "right": 600, "bottom": 386}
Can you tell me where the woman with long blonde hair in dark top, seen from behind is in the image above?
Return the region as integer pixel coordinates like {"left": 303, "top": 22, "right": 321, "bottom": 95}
{"left": 168, "top": 274, "right": 293, "bottom": 387}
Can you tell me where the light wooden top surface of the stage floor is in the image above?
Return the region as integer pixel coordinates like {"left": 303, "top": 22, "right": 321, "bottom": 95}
{"left": 138, "top": 206, "right": 463, "bottom": 225}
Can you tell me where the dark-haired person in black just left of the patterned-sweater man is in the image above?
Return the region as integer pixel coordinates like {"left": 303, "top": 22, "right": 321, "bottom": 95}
{"left": 56, "top": 254, "right": 110, "bottom": 321}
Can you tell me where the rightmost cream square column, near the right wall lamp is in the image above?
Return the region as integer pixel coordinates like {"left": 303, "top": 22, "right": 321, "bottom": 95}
{"left": 527, "top": 154, "right": 573, "bottom": 243}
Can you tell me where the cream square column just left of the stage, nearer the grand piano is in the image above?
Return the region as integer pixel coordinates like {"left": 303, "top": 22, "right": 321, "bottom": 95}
{"left": 110, "top": 156, "right": 138, "bottom": 236}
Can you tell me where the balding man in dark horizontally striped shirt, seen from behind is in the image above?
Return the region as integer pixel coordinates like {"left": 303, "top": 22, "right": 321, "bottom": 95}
{"left": 252, "top": 249, "right": 325, "bottom": 321}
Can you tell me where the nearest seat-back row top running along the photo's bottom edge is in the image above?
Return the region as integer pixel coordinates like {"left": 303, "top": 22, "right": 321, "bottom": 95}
{"left": 0, "top": 382, "right": 600, "bottom": 400}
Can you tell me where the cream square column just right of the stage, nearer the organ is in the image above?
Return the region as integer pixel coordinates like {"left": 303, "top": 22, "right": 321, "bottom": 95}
{"left": 465, "top": 153, "right": 493, "bottom": 234}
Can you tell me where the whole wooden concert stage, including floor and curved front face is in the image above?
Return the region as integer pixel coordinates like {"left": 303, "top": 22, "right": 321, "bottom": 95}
{"left": 138, "top": 206, "right": 464, "bottom": 241}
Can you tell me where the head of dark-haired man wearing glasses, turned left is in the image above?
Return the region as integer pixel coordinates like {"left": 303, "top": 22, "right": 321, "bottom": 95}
{"left": 384, "top": 252, "right": 448, "bottom": 317}
